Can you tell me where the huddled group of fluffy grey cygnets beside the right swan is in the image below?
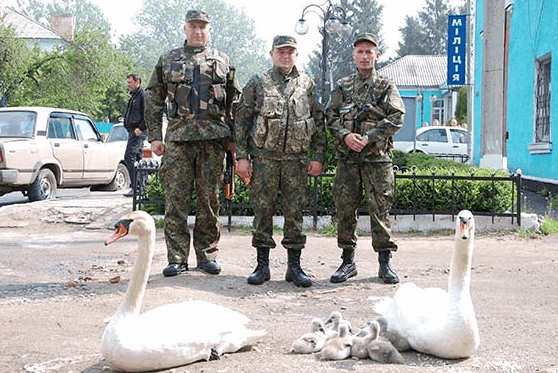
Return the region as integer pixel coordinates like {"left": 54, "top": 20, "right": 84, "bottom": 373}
{"left": 291, "top": 311, "right": 410, "bottom": 364}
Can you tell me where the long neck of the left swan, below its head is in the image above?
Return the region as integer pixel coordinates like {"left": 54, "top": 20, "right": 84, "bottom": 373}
{"left": 116, "top": 231, "right": 155, "bottom": 317}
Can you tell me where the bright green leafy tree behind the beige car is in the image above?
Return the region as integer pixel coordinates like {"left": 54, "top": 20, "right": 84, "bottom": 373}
{"left": 23, "top": 30, "right": 138, "bottom": 121}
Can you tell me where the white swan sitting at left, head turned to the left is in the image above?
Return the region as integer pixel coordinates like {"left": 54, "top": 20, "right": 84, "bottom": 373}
{"left": 101, "top": 211, "right": 265, "bottom": 372}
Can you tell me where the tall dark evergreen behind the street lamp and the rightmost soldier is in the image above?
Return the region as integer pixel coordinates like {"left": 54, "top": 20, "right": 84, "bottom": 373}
{"left": 306, "top": 0, "right": 383, "bottom": 102}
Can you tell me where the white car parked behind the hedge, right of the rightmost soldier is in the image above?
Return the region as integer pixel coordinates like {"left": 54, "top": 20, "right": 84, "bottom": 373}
{"left": 394, "top": 126, "right": 469, "bottom": 160}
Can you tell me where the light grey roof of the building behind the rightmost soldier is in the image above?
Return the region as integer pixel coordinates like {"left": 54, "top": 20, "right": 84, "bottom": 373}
{"left": 378, "top": 55, "right": 447, "bottom": 88}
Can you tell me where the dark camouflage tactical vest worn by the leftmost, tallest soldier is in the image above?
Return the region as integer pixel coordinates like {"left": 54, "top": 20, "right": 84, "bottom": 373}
{"left": 163, "top": 48, "right": 230, "bottom": 121}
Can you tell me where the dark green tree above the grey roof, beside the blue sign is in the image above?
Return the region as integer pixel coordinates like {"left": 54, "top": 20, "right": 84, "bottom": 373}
{"left": 397, "top": 0, "right": 464, "bottom": 58}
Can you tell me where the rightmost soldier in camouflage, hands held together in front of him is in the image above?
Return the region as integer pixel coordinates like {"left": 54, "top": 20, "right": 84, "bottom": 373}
{"left": 327, "top": 34, "right": 405, "bottom": 284}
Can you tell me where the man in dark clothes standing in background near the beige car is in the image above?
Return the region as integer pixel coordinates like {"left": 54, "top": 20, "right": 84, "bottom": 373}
{"left": 124, "top": 73, "right": 147, "bottom": 197}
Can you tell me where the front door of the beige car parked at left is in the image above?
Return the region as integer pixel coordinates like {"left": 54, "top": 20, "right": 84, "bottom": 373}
{"left": 74, "top": 116, "right": 115, "bottom": 182}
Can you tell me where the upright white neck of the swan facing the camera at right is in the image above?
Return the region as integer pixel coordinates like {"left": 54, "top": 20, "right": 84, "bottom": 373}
{"left": 448, "top": 235, "right": 475, "bottom": 298}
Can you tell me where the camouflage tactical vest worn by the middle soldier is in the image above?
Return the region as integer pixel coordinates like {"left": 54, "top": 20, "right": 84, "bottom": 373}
{"left": 252, "top": 73, "right": 316, "bottom": 153}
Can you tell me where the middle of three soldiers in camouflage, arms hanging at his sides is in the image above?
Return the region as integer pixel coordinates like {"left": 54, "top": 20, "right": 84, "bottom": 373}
{"left": 235, "top": 36, "right": 327, "bottom": 287}
